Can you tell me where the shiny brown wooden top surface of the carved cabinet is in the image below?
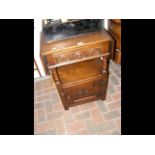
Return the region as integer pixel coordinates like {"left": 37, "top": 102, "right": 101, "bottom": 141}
{"left": 40, "top": 29, "right": 112, "bottom": 55}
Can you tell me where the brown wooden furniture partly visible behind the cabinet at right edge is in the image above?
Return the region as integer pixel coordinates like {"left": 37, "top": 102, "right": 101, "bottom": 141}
{"left": 108, "top": 19, "right": 121, "bottom": 64}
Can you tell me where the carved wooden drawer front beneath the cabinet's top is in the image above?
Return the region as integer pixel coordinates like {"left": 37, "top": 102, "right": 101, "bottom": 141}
{"left": 46, "top": 42, "right": 109, "bottom": 65}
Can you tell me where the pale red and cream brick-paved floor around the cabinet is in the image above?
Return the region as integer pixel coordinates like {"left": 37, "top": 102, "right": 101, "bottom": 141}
{"left": 34, "top": 61, "right": 121, "bottom": 135}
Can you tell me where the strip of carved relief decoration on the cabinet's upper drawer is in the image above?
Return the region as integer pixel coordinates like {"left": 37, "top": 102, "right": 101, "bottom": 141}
{"left": 53, "top": 47, "right": 102, "bottom": 63}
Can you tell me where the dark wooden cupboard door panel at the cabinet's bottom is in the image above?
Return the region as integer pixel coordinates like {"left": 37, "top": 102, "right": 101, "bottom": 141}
{"left": 64, "top": 81, "right": 95, "bottom": 105}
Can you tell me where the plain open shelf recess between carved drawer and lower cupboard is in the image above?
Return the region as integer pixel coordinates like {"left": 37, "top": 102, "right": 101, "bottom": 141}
{"left": 57, "top": 58, "right": 102, "bottom": 84}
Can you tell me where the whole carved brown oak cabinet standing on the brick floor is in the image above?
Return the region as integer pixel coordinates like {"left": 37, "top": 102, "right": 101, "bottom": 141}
{"left": 40, "top": 29, "right": 114, "bottom": 110}
